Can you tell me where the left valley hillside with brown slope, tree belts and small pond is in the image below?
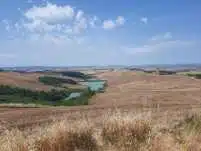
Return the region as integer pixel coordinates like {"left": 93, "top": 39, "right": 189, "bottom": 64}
{"left": 0, "top": 71, "right": 95, "bottom": 106}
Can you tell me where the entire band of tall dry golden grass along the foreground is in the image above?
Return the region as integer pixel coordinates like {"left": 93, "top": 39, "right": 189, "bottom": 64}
{"left": 0, "top": 112, "right": 201, "bottom": 151}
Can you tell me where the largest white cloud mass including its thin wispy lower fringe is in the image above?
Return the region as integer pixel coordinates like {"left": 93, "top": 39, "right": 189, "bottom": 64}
{"left": 18, "top": 2, "right": 103, "bottom": 34}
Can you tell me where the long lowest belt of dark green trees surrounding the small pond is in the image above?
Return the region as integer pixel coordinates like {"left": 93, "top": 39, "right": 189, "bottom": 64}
{"left": 0, "top": 85, "right": 95, "bottom": 106}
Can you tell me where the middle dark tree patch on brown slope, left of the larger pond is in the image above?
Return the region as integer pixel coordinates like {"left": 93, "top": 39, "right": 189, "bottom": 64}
{"left": 39, "top": 76, "right": 77, "bottom": 86}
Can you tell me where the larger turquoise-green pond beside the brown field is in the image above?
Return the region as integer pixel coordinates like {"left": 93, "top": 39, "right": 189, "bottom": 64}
{"left": 81, "top": 80, "right": 106, "bottom": 92}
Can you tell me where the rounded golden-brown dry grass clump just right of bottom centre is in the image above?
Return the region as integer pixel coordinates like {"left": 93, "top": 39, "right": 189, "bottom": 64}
{"left": 101, "top": 113, "right": 151, "bottom": 150}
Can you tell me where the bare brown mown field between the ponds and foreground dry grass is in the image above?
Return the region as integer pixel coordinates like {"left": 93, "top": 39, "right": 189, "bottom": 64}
{"left": 0, "top": 71, "right": 201, "bottom": 130}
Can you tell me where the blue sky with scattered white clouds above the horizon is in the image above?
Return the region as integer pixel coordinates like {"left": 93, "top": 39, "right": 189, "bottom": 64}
{"left": 0, "top": 0, "right": 201, "bottom": 66}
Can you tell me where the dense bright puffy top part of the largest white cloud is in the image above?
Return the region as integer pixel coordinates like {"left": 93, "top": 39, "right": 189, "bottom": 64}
{"left": 25, "top": 3, "right": 74, "bottom": 23}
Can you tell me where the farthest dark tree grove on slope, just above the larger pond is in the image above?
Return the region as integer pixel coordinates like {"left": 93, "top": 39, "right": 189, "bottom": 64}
{"left": 61, "top": 71, "right": 92, "bottom": 80}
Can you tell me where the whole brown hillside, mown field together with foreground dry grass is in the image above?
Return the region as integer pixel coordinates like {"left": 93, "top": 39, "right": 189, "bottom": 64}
{"left": 0, "top": 71, "right": 201, "bottom": 151}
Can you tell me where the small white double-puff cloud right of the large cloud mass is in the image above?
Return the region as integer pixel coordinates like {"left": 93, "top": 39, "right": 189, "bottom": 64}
{"left": 103, "top": 16, "right": 125, "bottom": 30}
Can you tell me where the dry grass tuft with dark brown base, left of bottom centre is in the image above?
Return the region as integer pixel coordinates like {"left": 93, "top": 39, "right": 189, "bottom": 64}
{"left": 35, "top": 119, "right": 98, "bottom": 151}
